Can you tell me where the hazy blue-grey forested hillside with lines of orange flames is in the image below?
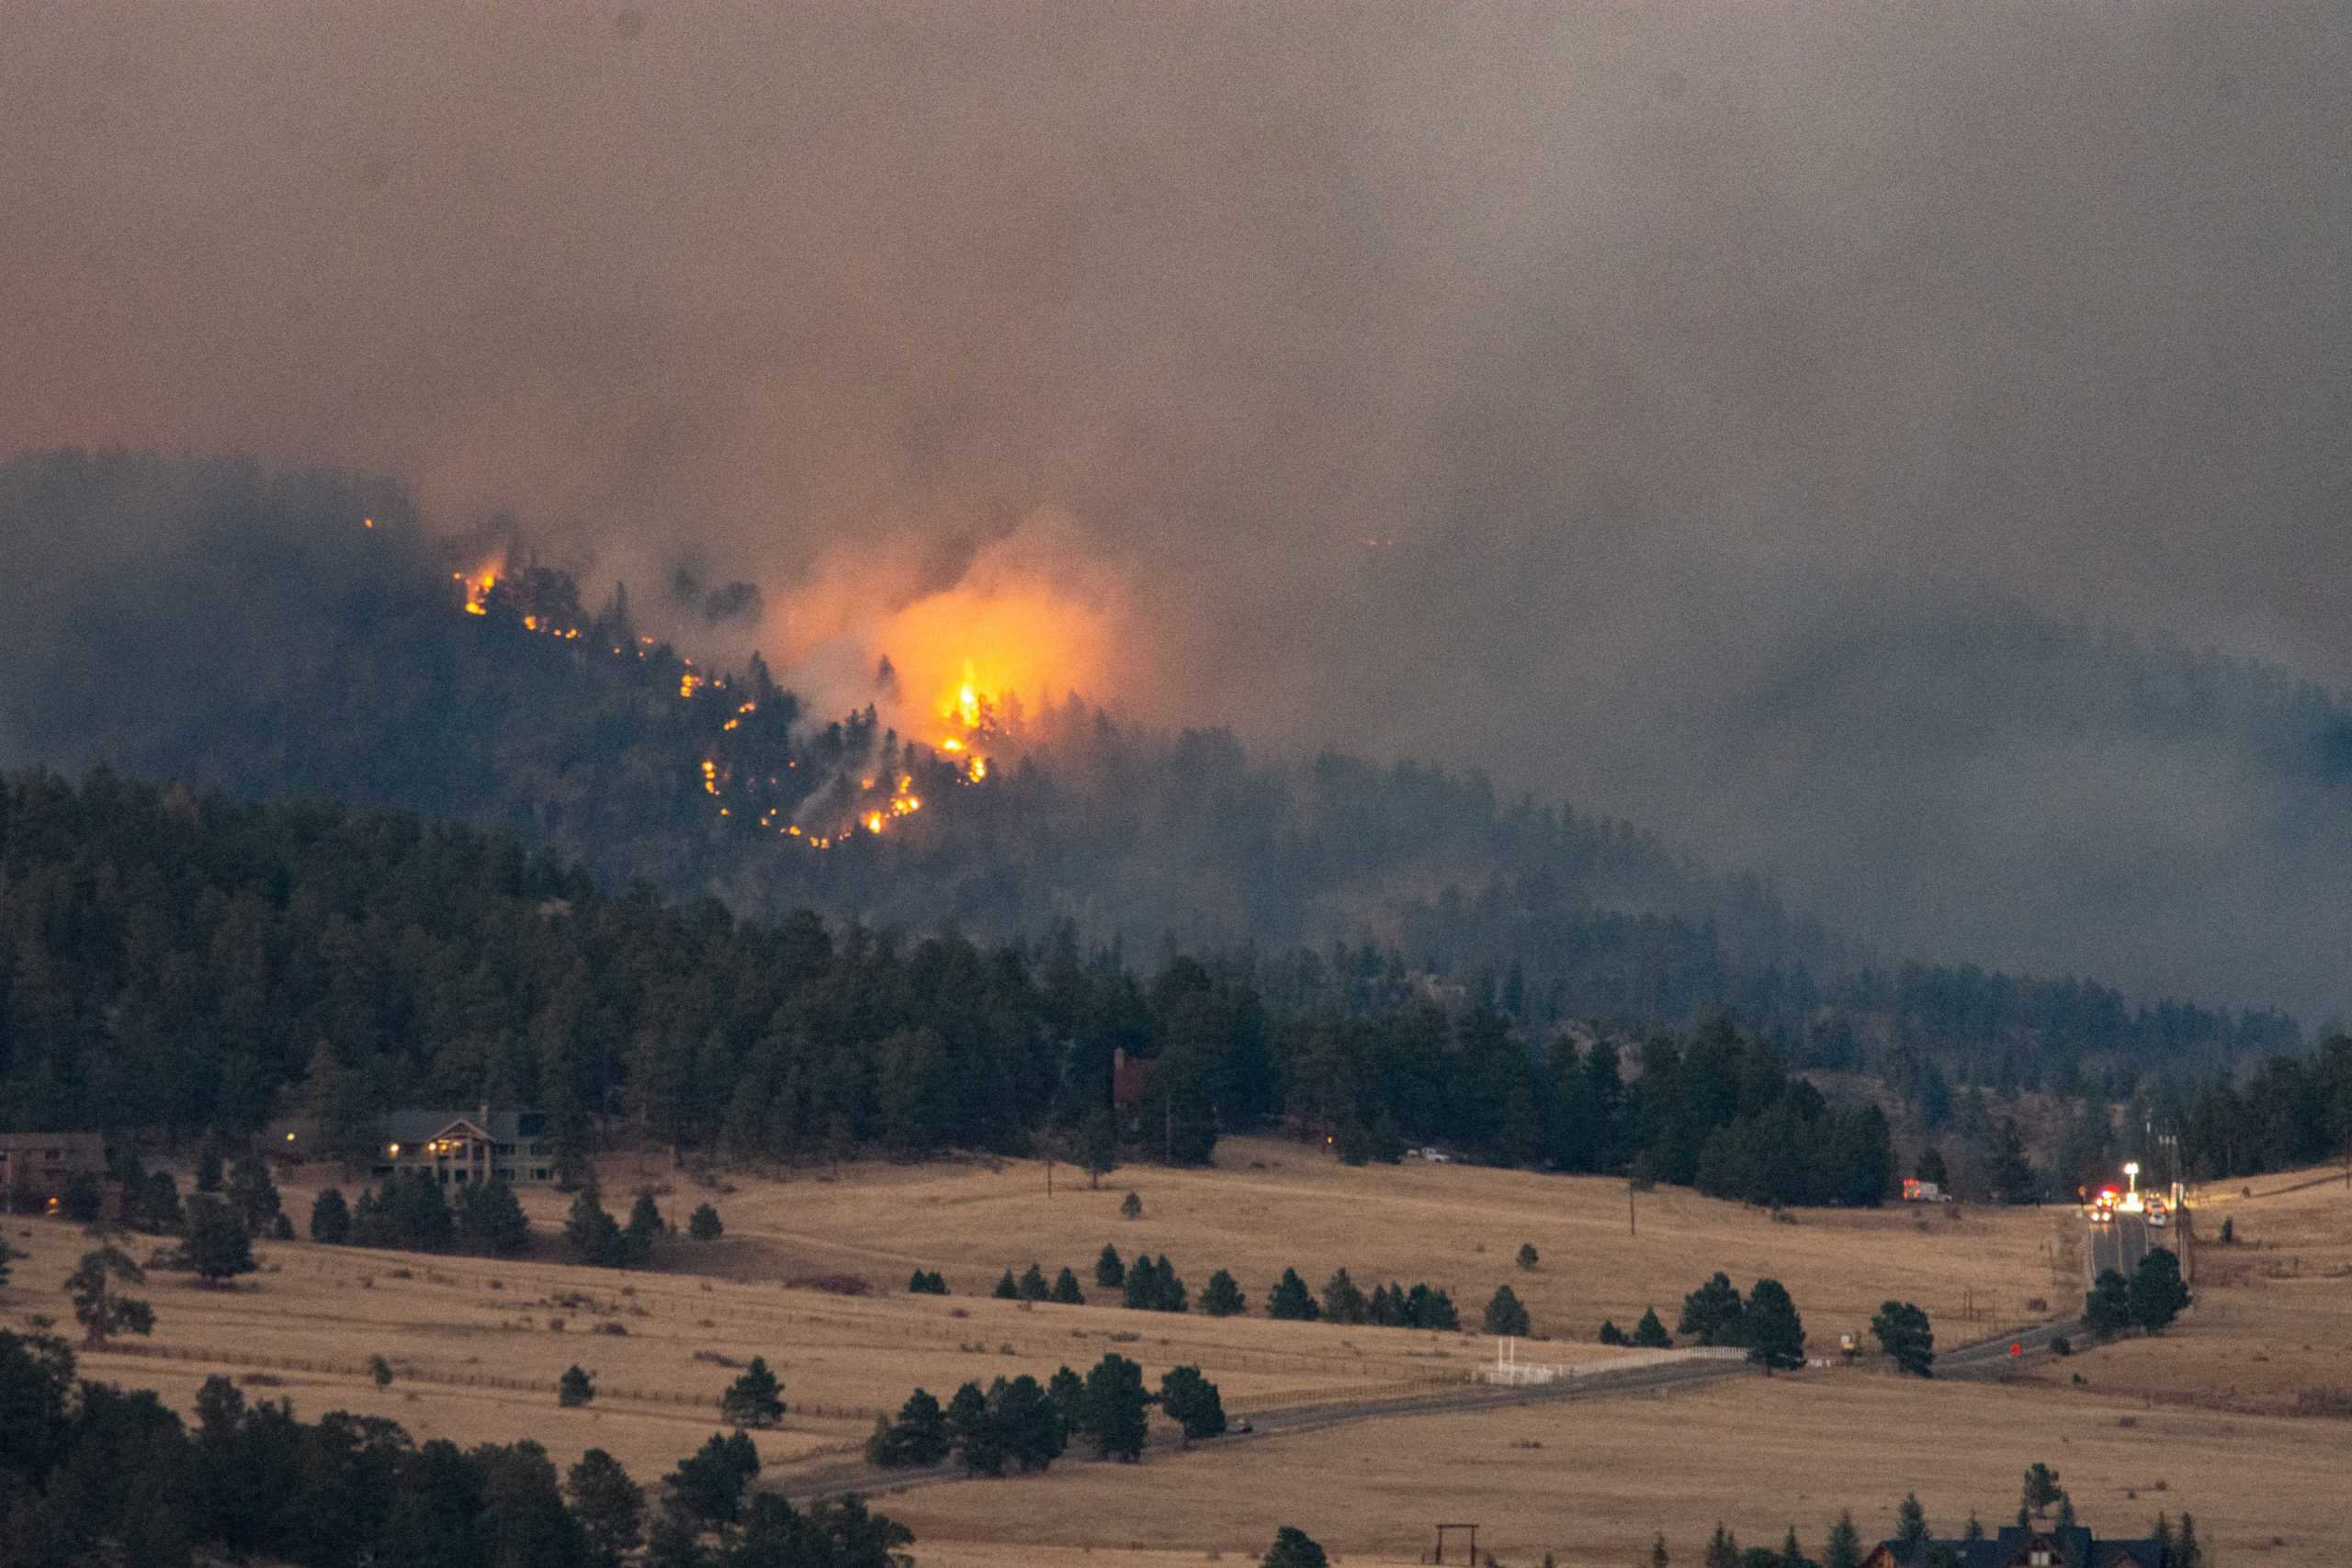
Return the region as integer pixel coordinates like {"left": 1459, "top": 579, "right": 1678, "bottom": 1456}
{"left": 0, "top": 454, "right": 2310, "bottom": 1086}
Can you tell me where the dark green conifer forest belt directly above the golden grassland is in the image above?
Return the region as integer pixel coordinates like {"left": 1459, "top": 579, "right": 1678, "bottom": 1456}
{"left": 0, "top": 771, "right": 2324, "bottom": 1189}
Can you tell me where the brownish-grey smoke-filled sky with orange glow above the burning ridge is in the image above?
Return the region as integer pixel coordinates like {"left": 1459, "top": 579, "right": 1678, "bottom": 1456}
{"left": 0, "top": 0, "right": 2352, "bottom": 1010}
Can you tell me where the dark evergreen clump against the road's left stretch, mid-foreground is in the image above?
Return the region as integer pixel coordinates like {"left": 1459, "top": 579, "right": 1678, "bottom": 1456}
{"left": 865, "top": 1352, "right": 1226, "bottom": 1476}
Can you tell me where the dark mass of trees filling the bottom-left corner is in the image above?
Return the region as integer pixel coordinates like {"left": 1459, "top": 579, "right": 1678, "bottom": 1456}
{"left": 0, "top": 1331, "right": 912, "bottom": 1568}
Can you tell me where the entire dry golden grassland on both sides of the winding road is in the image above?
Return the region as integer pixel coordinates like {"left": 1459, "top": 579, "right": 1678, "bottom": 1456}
{"left": 0, "top": 1140, "right": 2352, "bottom": 1568}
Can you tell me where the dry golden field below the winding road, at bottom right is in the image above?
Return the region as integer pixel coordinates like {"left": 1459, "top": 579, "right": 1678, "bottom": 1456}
{"left": 882, "top": 1371, "right": 2352, "bottom": 1568}
